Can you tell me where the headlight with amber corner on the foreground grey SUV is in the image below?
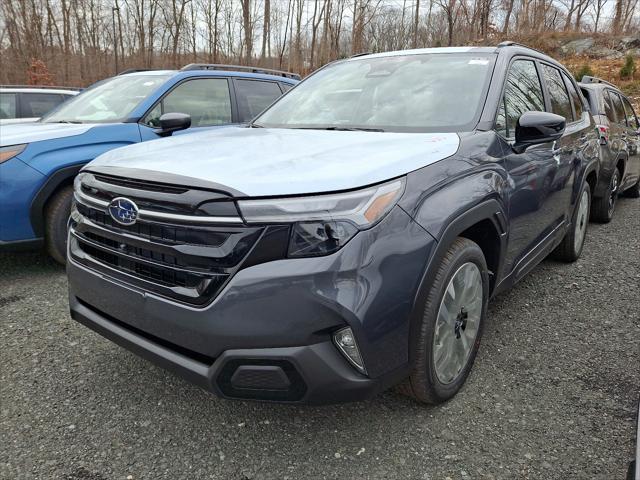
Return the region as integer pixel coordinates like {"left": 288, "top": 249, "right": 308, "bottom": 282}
{"left": 238, "top": 179, "right": 404, "bottom": 257}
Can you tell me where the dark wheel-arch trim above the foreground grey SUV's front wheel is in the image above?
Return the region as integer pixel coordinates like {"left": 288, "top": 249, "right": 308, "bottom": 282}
{"left": 409, "top": 198, "right": 507, "bottom": 362}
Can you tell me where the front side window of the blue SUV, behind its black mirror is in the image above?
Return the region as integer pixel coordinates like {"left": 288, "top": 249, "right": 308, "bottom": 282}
{"left": 143, "top": 78, "right": 232, "bottom": 127}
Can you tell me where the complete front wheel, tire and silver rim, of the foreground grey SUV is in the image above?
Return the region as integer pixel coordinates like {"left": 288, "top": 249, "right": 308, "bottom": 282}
{"left": 399, "top": 238, "right": 489, "bottom": 404}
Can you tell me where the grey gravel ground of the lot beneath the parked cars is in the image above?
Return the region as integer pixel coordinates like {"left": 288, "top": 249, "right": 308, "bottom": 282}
{"left": 0, "top": 199, "right": 640, "bottom": 480}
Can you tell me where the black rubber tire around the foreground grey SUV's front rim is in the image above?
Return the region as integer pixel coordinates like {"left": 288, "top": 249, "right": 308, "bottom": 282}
{"left": 398, "top": 238, "right": 489, "bottom": 404}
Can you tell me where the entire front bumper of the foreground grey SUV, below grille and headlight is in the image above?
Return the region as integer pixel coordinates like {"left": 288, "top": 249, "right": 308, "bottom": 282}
{"left": 67, "top": 207, "right": 435, "bottom": 403}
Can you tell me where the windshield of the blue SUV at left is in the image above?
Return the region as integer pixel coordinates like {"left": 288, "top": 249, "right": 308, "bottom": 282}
{"left": 42, "top": 75, "right": 170, "bottom": 123}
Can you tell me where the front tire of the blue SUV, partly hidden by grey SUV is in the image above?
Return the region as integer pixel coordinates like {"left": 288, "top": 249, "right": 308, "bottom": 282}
{"left": 44, "top": 185, "right": 73, "bottom": 265}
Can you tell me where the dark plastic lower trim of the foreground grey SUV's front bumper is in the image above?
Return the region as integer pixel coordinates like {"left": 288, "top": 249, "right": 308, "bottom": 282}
{"left": 71, "top": 298, "right": 405, "bottom": 404}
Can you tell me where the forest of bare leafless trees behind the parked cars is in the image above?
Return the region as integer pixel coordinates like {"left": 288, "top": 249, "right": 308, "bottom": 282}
{"left": 0, "top": 0, "right": 640, "bottom": 86}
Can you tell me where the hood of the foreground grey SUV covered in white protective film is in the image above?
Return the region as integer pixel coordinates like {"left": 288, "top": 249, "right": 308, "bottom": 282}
{"left": 90, "top": 127, "right": 459, "bottom": 197}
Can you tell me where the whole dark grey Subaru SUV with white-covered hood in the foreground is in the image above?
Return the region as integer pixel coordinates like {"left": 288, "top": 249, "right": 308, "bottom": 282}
{"left": 67, "top": 43, "right": 598, "bottom": 403}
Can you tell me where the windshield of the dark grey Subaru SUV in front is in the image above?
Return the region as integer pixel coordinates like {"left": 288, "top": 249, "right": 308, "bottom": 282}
{"left": 254, "top": 53, "right": 495, "bottom": 132}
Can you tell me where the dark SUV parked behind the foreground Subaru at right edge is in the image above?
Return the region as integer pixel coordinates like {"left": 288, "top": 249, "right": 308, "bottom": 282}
{"left": 580, "top": 76, "right": 640, "bottom": 222}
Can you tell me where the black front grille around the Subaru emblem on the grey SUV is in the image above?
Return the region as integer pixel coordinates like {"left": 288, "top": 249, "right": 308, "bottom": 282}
{"left": 69, "top": 174, "right": 264, "bottom": 306}
